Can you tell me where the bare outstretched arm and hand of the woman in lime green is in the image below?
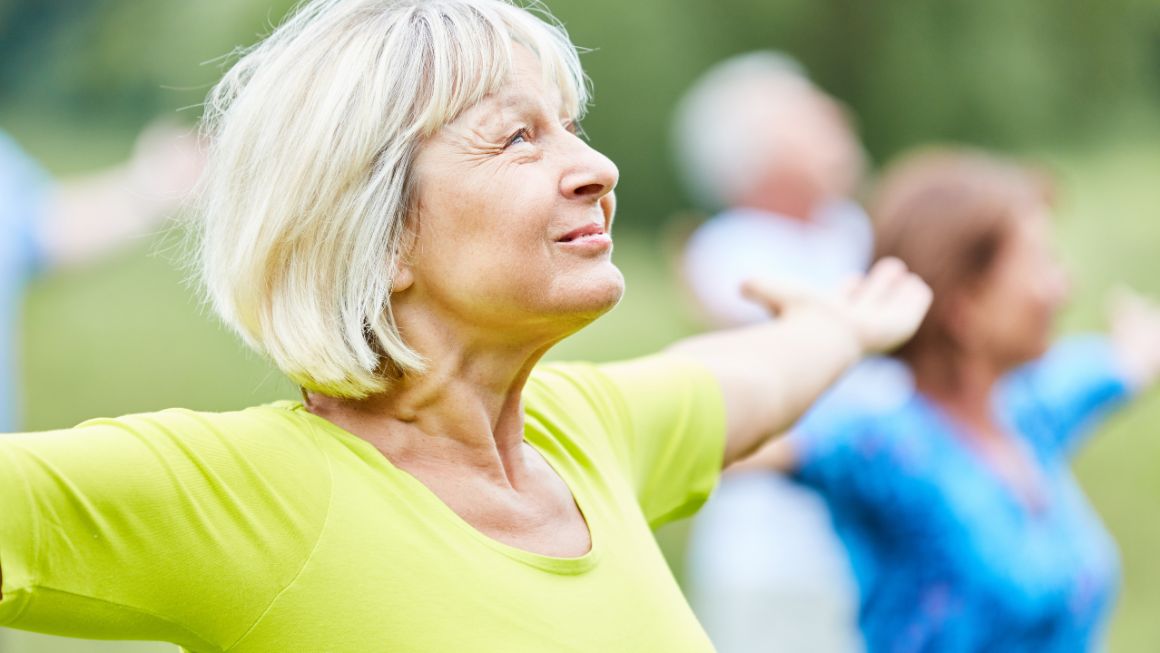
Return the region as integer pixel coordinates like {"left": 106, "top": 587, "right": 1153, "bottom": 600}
{"left": 669, "top": 259, "right": 930, "bottom": 466}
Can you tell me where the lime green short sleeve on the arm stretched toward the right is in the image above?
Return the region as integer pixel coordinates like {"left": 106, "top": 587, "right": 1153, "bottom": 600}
{"left": 531, "top": 355, "right": 725, "bottom": 528}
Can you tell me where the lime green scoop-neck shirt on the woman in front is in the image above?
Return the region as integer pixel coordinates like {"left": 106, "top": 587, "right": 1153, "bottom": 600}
{"left": 0, "top": 357, "right": 725, "bottom": 653}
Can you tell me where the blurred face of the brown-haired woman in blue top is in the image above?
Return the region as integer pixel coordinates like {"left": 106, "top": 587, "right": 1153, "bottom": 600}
{"left": 965, "top": 206, "right": 1068, "bottom": 370}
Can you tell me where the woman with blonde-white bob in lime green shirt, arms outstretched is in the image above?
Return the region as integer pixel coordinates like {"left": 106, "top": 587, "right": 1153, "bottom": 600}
{"left": 0, "top": 0, "right": 929, "bottom": 653}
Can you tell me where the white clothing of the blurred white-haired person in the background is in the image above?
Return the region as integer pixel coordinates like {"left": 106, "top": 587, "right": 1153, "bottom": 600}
{"left": 683, "top": 202, "right": 872, "bottom": 653}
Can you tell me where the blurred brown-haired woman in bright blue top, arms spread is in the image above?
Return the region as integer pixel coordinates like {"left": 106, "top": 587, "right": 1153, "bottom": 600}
{"left": 746, "top": 151, "right": 1160, "bottom": 653}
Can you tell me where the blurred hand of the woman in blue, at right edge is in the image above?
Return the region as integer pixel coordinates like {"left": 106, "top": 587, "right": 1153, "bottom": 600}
{"left": 1109, "top": 288, "right": 1160, "bottom": 389}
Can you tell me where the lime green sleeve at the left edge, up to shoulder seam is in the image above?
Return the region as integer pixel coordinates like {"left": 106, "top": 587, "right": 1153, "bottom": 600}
{"left": 0, "top": 411, "right": 328, "bottom": 651}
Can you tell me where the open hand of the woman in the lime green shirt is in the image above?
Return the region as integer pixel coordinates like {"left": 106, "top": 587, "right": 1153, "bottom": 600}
{"left": 742, "top": 259, "right": 931, "bottom": 355}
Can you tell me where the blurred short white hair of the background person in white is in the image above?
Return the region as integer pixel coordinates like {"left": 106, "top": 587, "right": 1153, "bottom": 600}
{"left": 673, "top": 51, "right": 812, "bottom": 209}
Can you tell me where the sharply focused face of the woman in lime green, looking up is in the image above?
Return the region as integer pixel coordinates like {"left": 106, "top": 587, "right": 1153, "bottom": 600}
{"left": 396, "top": 46, "right": 624, "bottom": 335}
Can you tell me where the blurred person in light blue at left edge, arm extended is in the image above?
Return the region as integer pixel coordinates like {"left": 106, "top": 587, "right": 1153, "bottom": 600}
{"left": 0, "top": 123, "right": 201, "bottom": 433}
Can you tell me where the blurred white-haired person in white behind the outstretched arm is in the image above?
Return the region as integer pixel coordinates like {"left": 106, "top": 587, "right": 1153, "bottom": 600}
{"left": 673, "top": 51, "right": 909, "bottom": 653}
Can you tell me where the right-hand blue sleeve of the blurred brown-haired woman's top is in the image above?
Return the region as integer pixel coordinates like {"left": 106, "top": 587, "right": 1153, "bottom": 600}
{"left": 1001, "top": 335, "right": 1132, "bottom": 455}
